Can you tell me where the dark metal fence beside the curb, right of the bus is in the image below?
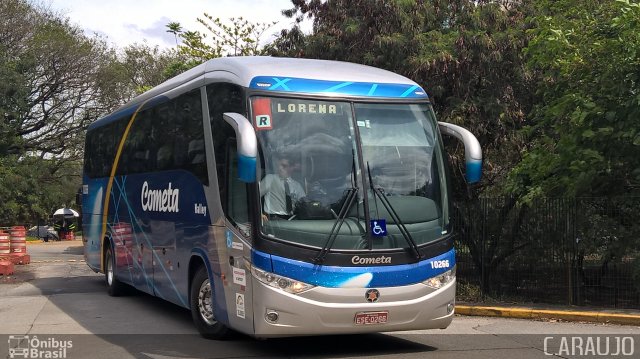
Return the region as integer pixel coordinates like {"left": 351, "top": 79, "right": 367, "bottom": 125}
{"left": 454, "top": 198, "right": 640, "bottom": 308}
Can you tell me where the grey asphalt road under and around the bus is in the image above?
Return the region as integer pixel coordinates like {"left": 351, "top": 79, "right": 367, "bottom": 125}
{"left": 0, "top": 241, "right": 640, "bottom": 359}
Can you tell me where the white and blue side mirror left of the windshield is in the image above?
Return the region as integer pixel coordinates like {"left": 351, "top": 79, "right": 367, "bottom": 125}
{"left": 223, "top": 112, "right": 258, "bottom": 183}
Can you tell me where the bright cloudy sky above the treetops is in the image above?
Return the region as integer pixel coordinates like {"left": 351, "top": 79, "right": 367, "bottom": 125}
{"left": 43, "top": 0, "right": 304, "bottom": 49}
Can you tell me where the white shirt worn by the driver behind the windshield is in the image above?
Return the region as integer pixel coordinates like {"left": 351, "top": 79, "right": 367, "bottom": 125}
{"left": 260, "top": 174, "right": 306, "bottom": 215}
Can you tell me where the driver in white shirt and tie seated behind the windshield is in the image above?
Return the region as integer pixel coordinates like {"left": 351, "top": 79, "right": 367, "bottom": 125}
{"left": 260, "top": 155, "right": 305, "bottom": 219}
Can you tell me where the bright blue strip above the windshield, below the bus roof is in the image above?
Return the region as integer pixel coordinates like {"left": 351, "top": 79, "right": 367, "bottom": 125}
{"left": 249, "top": 76, "right": 429, "bottom": 99}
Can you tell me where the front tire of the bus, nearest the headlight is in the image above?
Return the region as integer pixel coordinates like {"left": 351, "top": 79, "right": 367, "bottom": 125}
{"left": 189, "top": 266, "right": 229, "bottom": 339}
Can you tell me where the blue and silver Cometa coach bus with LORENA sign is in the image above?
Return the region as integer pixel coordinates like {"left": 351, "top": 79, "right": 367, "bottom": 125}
{"left": 81, "top": 57, "right": 482, "bottom": 338}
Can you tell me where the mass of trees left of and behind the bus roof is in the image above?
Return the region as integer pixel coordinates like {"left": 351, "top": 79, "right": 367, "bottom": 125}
{"left": 0, "top": 0, "right": 272, "bottom": 225}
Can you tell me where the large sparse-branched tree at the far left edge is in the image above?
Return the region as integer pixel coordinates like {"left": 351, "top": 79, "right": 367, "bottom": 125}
{"left": 0, "top": 0, "right": 115, "bottom": 226}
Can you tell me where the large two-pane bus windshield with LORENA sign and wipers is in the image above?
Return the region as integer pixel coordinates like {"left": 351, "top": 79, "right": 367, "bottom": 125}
{"left": 251, "top": 97, "right": 449, "bottom": 251}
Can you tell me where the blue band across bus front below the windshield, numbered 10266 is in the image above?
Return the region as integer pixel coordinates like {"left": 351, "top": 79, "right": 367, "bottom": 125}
{"left": 251, "top": 249, "right": 456, "bottom": 288}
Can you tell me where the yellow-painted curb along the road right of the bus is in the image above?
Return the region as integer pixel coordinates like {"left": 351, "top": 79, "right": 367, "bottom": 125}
{"left": 456, "top": 305, "right": 640, "bottom": 326}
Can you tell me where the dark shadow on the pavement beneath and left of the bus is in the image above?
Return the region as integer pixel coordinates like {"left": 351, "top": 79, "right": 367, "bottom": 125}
{"left": 15, "top": 274, "right": 436, "bottom": 358}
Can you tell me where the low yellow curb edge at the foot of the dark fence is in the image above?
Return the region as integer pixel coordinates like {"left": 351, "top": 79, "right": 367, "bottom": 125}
{"left": 456, "top": 302, "right": 640, "bottom": 326}
